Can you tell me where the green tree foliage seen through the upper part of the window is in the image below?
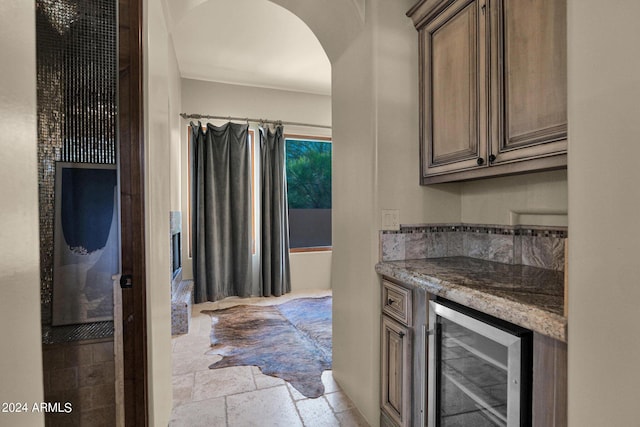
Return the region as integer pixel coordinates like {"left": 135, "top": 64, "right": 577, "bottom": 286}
{"left": 286, "top": 139, "right": 331, "bottom": 209}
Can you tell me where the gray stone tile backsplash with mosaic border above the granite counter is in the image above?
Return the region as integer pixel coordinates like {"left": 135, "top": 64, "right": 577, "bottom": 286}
{"left": 380, "top": 224, "right": 568, "bottom": 271}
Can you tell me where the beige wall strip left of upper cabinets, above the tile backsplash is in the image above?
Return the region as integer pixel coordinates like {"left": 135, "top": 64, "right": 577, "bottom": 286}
{"left": 372, "top": 1, "right": 461, "bottom": 230}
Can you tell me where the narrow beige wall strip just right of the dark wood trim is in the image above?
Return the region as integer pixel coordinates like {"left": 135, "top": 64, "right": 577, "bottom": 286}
{"left": 143, "top": 0, "right": 180, "bottom": 426}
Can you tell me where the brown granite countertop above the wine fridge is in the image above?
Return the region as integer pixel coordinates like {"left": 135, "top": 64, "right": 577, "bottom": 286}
{"left": 376, "top": 257, "right": 567, "bottom": 342}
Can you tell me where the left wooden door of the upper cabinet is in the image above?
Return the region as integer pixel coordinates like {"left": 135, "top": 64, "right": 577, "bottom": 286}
{"left": 420, "top": 0, "right": 487, "bottom": 177}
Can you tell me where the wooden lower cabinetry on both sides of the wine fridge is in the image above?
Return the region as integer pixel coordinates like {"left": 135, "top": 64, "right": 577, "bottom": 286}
{"left": 380, "top": 278, "right": 567, "bottom": 427}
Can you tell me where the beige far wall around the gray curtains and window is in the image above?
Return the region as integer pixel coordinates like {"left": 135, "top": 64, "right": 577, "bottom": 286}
{"left": 180, "top": 79, "right": 335, "bottom": 292}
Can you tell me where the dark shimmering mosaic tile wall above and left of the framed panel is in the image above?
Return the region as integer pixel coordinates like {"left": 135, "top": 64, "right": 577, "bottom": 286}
{"left": 36, "top": 0, "right": 117, "bottom": 332}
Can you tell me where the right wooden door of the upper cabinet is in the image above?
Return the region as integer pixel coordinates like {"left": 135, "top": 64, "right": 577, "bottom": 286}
{"left": 488, "top": 0, "right": 567, "bottom": 166}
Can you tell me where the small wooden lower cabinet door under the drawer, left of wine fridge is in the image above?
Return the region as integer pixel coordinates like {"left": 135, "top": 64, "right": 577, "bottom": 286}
{"left": 381, "top": 316, "right": 411, "bottom": 427}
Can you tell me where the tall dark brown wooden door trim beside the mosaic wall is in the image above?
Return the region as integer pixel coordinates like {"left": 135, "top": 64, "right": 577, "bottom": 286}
{"left": 118, "top": 0, "right": 149, "bottom": 426}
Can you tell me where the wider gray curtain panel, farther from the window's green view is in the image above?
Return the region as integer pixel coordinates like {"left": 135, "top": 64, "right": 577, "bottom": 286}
{"left": 191, "top": 123, "right": 252, "bottom": 303}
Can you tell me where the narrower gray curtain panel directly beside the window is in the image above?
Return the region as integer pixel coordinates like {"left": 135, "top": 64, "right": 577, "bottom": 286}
{"left": 260, "top": 126, "right": 291, "bottom": 296}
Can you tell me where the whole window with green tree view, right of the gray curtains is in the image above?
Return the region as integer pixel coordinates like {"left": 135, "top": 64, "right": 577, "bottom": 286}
{"left": 285, "top": 135, "right": 331, "bottom": 252}
